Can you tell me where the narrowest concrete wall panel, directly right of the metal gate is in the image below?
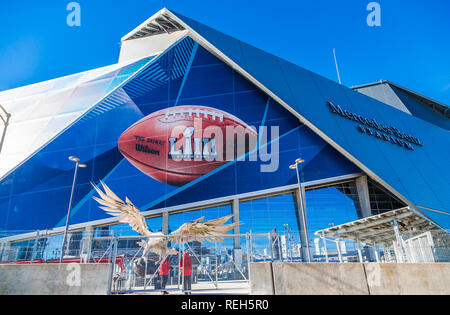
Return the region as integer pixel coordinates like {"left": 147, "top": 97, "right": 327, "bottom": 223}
{"left": 249, "top": 262, "right": 275, "bottom": 295}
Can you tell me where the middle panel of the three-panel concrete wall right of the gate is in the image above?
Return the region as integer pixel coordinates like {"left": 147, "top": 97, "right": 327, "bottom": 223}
{"left": 272, "top": 263, "right": 369, "bottom": 295}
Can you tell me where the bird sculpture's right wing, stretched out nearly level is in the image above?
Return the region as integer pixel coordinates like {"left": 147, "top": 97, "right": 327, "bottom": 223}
{"left": 171, "top": 215, "right": 241, "bottom": 243}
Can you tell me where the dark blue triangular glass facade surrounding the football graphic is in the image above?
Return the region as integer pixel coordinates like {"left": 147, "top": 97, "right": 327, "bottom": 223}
{"left": 0, "top": 37, "right": 360, "bottom": 235}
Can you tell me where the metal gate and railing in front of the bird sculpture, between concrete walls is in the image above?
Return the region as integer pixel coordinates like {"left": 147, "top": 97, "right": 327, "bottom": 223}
{"left": 95, "top": 234, "right": 268, "bottom": 294}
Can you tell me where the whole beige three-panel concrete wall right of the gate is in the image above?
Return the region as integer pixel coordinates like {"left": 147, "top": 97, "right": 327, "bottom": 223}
{"left": 250, "top": 263, "right": 450, "bottom": 295}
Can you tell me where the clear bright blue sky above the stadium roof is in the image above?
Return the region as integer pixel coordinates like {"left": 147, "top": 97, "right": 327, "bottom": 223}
{"left": 0, "top": 0, "right": 450, "bottom": 105}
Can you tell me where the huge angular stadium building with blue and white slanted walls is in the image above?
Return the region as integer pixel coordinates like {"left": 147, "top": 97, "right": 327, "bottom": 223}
{"left": 0, "top": 9, "right": 450, "bottom": 261}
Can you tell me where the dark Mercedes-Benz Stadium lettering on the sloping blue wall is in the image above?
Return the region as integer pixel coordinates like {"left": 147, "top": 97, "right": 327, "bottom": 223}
{"left": 328, "top": 102, "right": 423, "bottom": 151}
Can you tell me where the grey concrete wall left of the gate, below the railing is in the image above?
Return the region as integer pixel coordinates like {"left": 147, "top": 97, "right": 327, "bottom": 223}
{"left": 0, "top": 264, "right": 111, "bottom": 295}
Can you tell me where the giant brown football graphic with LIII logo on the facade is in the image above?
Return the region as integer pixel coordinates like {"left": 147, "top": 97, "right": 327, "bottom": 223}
{"left": 119, "top": 106, "right": 258, "bottom": 187}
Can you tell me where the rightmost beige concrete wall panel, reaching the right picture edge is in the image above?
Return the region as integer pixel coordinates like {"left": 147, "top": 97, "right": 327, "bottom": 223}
{"left": 365, "top": 263, "right": 450, "bottom": 295}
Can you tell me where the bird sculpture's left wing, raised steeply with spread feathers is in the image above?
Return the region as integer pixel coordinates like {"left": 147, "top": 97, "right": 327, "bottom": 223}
{"left": 92, "top": 181, "right": 151, "bottom": 236}
